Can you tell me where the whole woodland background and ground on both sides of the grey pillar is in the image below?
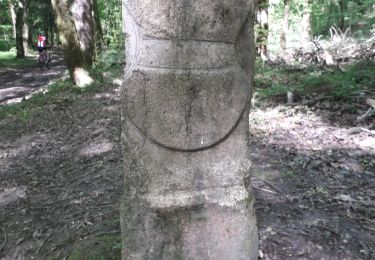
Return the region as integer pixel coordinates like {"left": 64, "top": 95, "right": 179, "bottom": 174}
{"left": 0, "top": 0, "right": 375, "bottom": 259}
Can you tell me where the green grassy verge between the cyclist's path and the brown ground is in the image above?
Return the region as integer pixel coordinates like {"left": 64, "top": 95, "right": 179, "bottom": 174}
{"left": 0, "top": 50, "right": 122, "bottom": 123}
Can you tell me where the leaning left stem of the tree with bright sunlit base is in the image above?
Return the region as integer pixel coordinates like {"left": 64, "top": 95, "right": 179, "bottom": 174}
{"left": 52, "top": 0, "right": 93, "bottom": 86}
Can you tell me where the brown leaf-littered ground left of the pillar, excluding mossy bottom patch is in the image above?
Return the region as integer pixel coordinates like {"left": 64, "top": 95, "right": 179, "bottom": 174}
{"left": 0, "top": 82, "right": 122, "bottom": 260}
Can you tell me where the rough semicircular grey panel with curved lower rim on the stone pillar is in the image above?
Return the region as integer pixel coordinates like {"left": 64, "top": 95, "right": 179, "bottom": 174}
{"left": 124, "top": 67, "right": 249, "bottom": 151}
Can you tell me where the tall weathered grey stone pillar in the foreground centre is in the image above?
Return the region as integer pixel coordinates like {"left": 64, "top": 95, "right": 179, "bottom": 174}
{"left": 121, "top": 0, "right": 258, "bottom": 259}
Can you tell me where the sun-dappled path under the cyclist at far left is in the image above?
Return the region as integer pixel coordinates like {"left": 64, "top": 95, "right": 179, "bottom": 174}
{"left": 0, "top": 51, "right": 66, "bottom": 105}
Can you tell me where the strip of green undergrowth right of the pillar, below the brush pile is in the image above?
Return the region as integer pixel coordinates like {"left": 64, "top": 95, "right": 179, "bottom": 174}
{"left": 255, "top": 61, "right": 375, "bottom": 100}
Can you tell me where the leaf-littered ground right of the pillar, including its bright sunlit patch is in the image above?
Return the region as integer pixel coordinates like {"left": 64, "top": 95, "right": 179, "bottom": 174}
{"left": 250, "top": 102, "right": 375, "bottom": 260}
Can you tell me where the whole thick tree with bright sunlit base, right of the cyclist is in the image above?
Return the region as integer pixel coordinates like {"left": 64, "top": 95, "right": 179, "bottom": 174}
{"left": 52, "top": 0, "right": 94, "bottom": 86}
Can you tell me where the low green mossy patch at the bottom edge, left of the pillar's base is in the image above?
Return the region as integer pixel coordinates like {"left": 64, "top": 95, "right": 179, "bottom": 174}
{"left": 68, "top": 235, "right": 121, "bottom": 260}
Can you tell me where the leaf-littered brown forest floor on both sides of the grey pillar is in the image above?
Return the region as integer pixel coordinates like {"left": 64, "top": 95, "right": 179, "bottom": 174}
{"left": 0, "top": 56, "right": 375, "bottom": 260}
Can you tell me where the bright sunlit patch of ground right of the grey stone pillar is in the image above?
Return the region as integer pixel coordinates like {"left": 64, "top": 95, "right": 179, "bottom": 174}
{"left": 249, "top": 106, "right": 375, "bottom": 154}
